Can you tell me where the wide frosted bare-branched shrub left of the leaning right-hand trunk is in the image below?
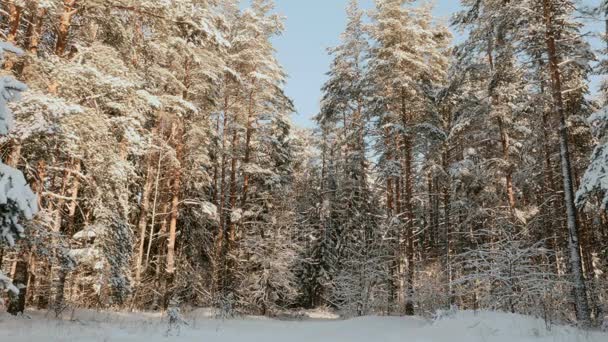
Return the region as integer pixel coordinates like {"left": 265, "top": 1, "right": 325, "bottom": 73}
{"left": 454, "top": 230, "right": 567, "bottom": 315}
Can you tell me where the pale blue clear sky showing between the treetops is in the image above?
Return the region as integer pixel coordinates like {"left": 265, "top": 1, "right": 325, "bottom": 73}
{"left": 266, "top": 0, "right": 459, "bottom": 127}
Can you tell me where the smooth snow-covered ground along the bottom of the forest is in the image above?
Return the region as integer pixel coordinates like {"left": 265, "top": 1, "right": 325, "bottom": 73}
{"left": 0, "top": 310, "right": 608, "bottom": 342}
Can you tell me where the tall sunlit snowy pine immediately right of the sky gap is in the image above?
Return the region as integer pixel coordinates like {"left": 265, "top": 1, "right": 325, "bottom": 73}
{"left": 368, "top": 0, "right": 450, "bottom": 315}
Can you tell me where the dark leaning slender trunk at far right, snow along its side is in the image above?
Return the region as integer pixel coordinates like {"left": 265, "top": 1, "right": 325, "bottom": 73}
{"left": 543, "top": 0, "right": 591, "bottom": 326}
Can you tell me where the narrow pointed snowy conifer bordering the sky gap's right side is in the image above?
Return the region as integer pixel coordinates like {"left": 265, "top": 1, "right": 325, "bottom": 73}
{"left": 313, "top": 0, "right": 384, "bottom": 315}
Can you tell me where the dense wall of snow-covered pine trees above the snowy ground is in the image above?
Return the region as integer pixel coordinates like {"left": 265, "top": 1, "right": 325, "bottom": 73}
{"left": 0, "top": 0, "right": 608, "bottom": 325}
